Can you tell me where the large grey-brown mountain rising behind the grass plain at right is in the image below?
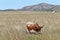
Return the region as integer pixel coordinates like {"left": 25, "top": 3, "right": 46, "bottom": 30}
{"left": 20, "top": 3, "right": 60, "bottom": 11}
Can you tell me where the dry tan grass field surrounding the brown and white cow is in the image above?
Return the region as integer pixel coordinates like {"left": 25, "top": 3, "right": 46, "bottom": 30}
{"left": 0, "top": 11, "right": 60, "bottom": 40}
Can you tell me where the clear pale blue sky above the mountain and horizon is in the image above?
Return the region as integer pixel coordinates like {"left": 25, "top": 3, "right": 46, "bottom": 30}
{"left": 0, "top": 0, "right": 60, "bottom": 10}
